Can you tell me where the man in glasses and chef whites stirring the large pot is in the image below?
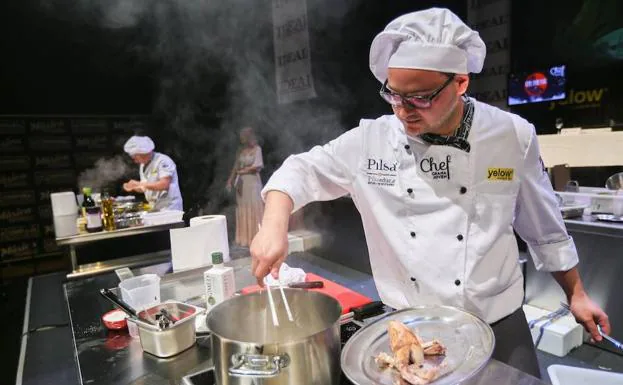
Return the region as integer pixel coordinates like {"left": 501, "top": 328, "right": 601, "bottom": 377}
{"left": 251, "top": 8, "right": 610, "bottom": 377}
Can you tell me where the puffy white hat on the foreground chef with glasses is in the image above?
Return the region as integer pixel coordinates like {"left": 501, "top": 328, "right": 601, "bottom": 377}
{"left": 370, "top": 8, "right": 487, "bottom": 83}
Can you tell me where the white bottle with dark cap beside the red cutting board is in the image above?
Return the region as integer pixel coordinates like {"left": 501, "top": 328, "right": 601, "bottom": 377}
{"left": 203, "top": 251, "right": 236, "bottom": 312}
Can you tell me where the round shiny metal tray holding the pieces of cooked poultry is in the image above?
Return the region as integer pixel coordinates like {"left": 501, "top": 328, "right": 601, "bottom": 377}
{"left": 341, "top": 306, "right": 495, "bottom": 385}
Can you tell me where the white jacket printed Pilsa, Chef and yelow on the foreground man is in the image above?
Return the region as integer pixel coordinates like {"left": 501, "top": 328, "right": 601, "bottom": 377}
{"left": 262, "top": 99, "right": 578, "bottom": 323}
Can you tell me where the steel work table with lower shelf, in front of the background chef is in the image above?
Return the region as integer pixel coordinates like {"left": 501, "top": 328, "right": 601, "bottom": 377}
{"left": 56, "top": 221, "right": 185, "bottom": 278}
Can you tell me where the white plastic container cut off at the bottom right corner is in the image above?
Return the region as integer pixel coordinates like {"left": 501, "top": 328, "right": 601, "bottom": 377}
{"left": 547, "top": 365, "right": 623, "bottom": 385}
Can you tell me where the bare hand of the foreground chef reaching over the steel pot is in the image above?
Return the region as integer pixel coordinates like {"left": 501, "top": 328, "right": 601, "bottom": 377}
{"left": 250, "top": 225, "right": 288, "bottom": 287}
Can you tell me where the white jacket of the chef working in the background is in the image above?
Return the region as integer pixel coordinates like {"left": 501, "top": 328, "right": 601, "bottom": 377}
{"left": 139, "top": 152, "right": 184, "bottom": 211}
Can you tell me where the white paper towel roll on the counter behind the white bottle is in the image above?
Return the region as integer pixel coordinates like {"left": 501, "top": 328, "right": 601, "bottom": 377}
{"left": 169, "top": 215, "right": 230, "bottom": 271}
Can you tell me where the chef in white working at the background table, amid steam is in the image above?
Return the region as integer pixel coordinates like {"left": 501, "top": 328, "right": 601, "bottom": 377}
{"left": 123, "top": 135, "right": 183, "bottom": 211}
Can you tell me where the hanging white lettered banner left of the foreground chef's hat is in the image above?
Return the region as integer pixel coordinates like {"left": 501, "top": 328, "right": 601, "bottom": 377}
{"left": 273, "top": 0, "right": 316, "bottom": 104}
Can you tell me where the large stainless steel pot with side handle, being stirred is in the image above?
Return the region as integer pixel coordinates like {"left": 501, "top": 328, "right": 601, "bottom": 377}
{"left": 206, "top": 289, "right": 341, "bottom": 385}
